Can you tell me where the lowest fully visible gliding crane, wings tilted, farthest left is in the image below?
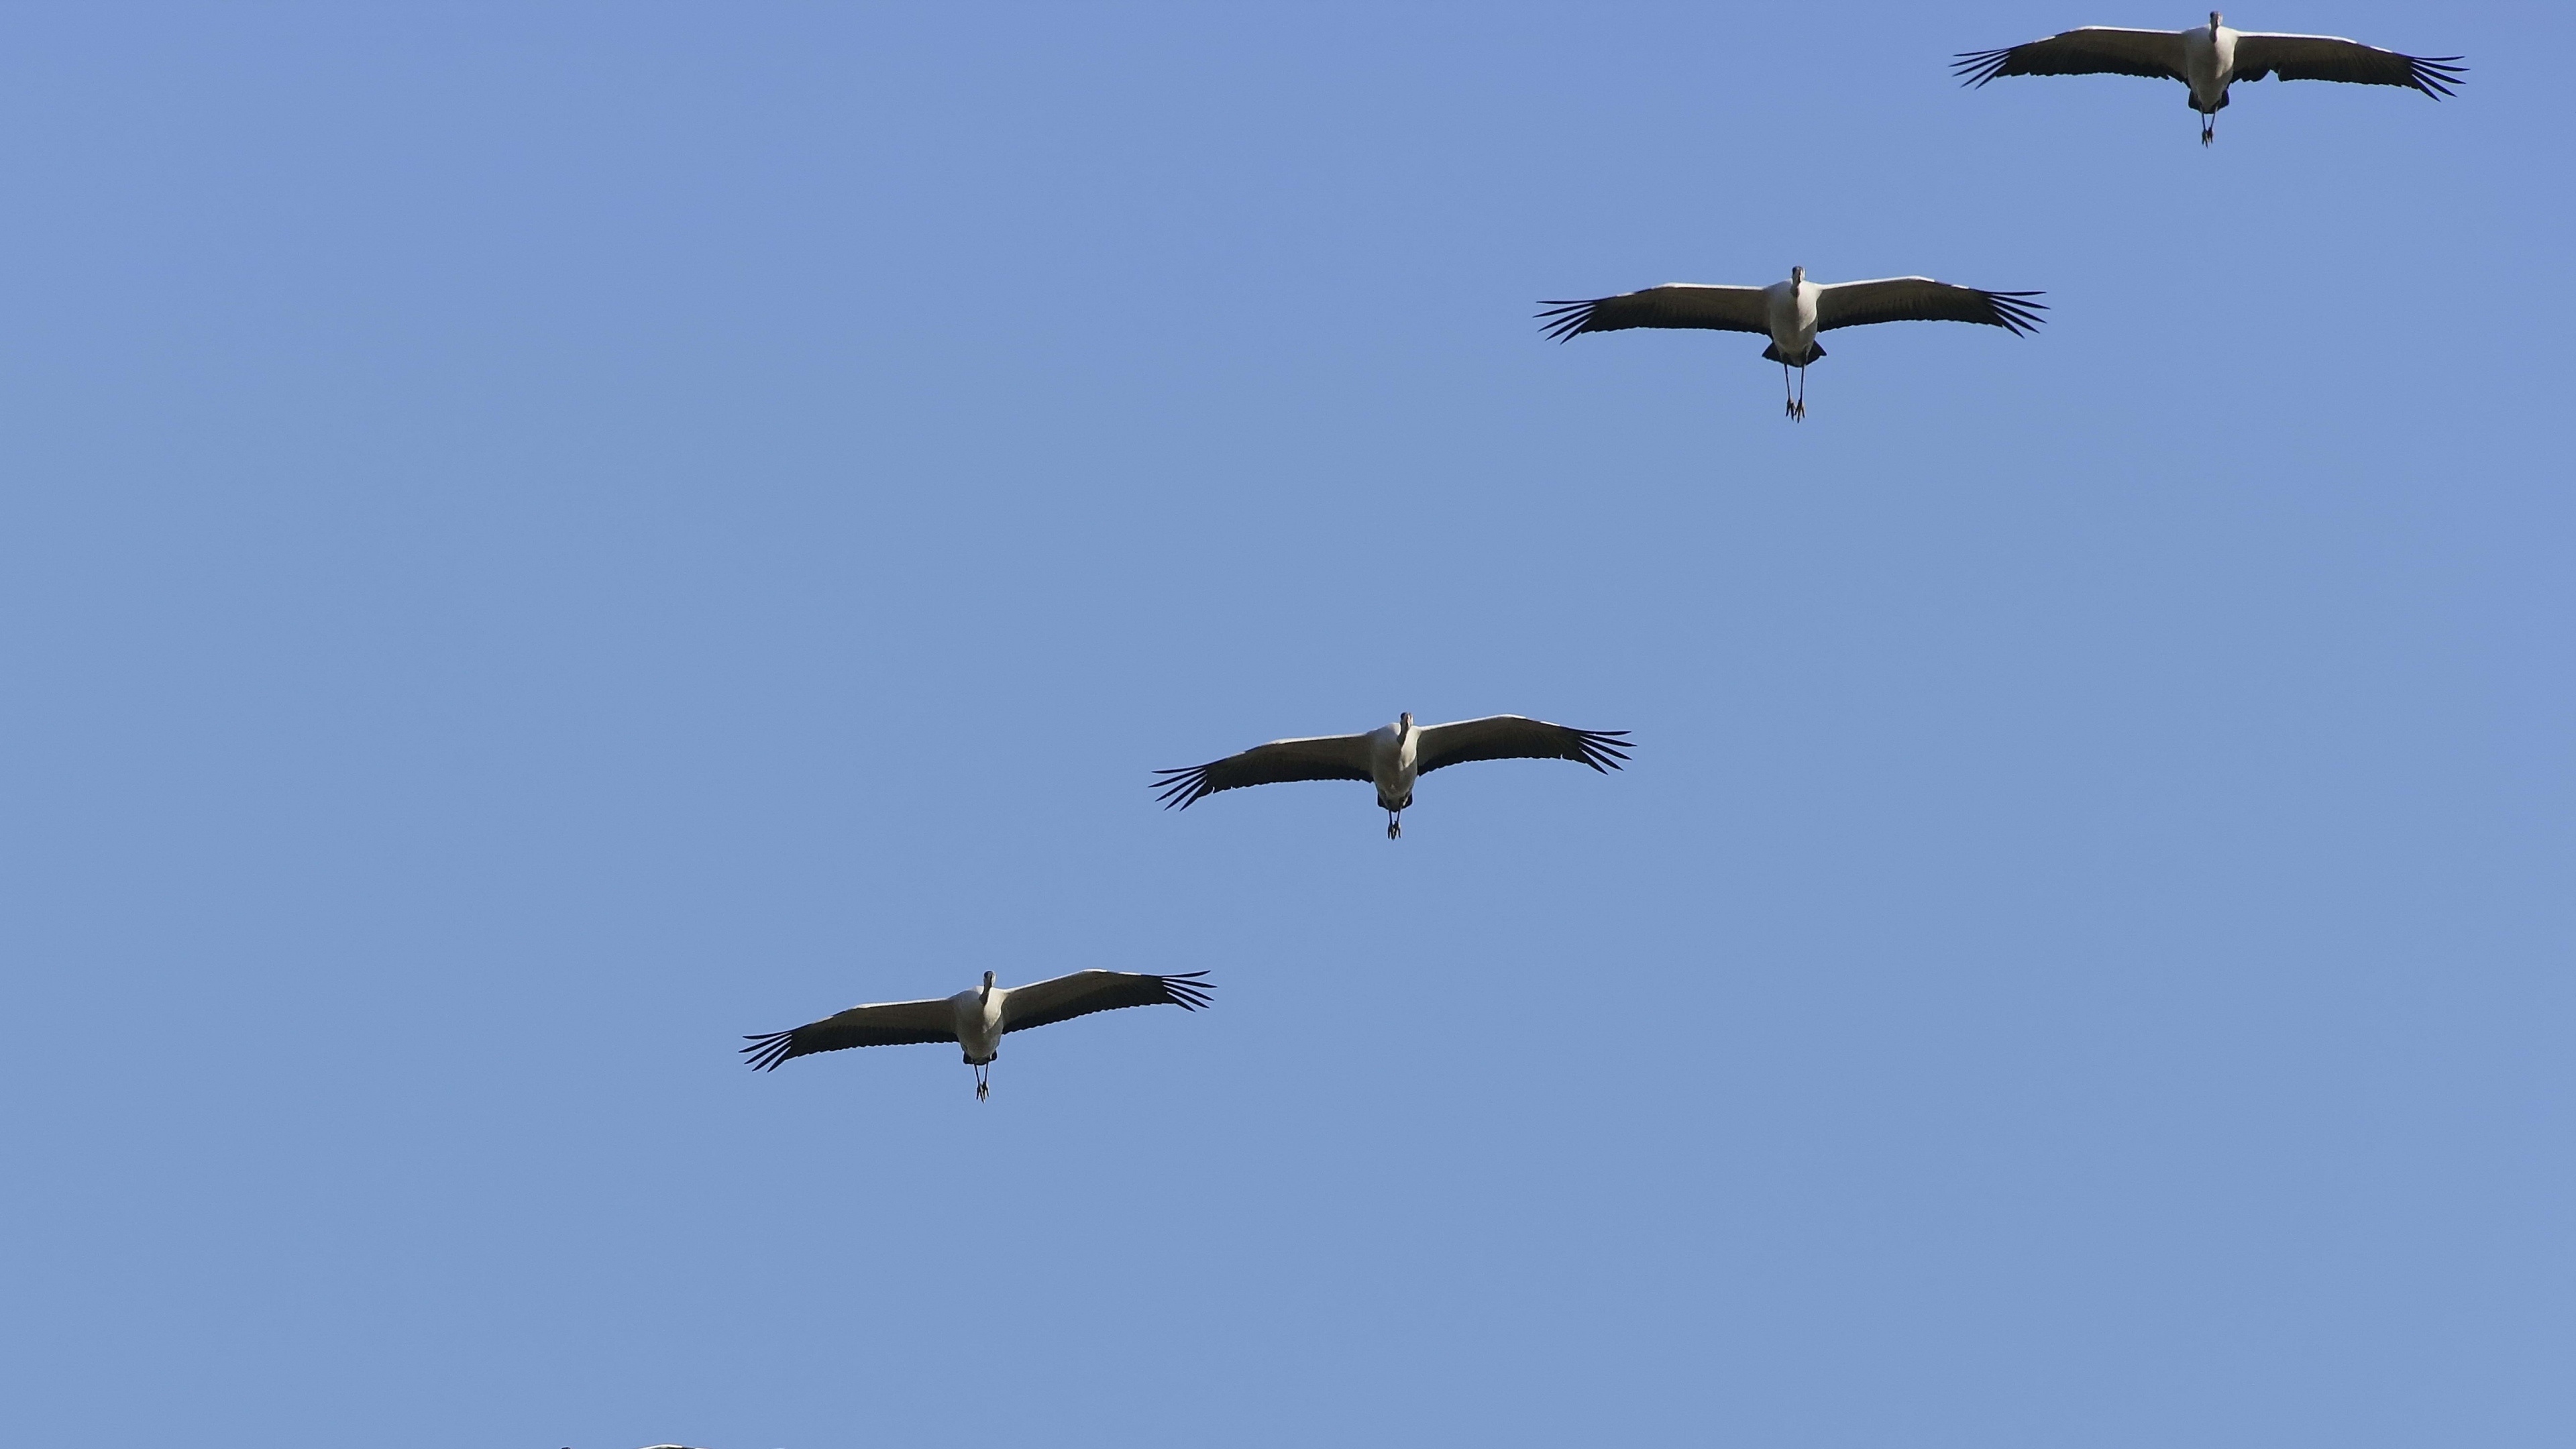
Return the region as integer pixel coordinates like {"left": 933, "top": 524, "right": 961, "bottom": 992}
{"left": 742, "top": 972, "right": 1214, "bottom": 1101}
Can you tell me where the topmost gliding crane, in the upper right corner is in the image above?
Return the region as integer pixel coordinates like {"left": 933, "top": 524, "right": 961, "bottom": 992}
{"left": 1953, "top": 10, "right": 2465, "bottom": 144}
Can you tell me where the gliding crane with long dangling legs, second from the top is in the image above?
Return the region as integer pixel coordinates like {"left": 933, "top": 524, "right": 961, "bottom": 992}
{"left": 1538, "top": 266, "right": 2048, "bottom": 420}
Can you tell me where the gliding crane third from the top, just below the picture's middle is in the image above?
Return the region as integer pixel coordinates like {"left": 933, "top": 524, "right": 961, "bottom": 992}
{"left": 1154, "top": 712, "right": 1628, "bottom": 841}
